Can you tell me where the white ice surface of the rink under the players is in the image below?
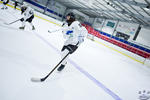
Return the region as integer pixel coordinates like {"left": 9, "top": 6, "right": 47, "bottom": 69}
{"left": 0, "top": 4, "right": 150, "bottom": 100}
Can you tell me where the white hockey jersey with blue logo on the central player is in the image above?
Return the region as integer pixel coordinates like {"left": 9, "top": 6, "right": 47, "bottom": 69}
{"left": 62, "top": 21, "right": 87, "bottom": 45}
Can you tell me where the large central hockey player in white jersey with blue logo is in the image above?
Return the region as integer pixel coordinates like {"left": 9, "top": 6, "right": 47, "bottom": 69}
{"left": 57, "top": 13, "right": 87, "bottom": 71}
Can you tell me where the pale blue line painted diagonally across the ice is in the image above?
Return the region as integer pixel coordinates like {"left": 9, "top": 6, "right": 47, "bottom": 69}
{"left": 34, "top": 32, "right": 122, "bottom": 100}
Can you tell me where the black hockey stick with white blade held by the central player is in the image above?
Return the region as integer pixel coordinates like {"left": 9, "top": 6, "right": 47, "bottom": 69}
{"left": 31, "top": 53, "right": 70, "bottom": 82}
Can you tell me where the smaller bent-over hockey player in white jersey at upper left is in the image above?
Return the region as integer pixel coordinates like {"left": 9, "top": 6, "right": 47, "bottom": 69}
{"left": 19, "top": 4, "right": 35, "bottom": 30}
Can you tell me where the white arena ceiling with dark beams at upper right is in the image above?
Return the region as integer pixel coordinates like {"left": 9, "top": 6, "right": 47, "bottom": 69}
{"left": 55, "top": 0, "right": 150, "bottom": 27}
